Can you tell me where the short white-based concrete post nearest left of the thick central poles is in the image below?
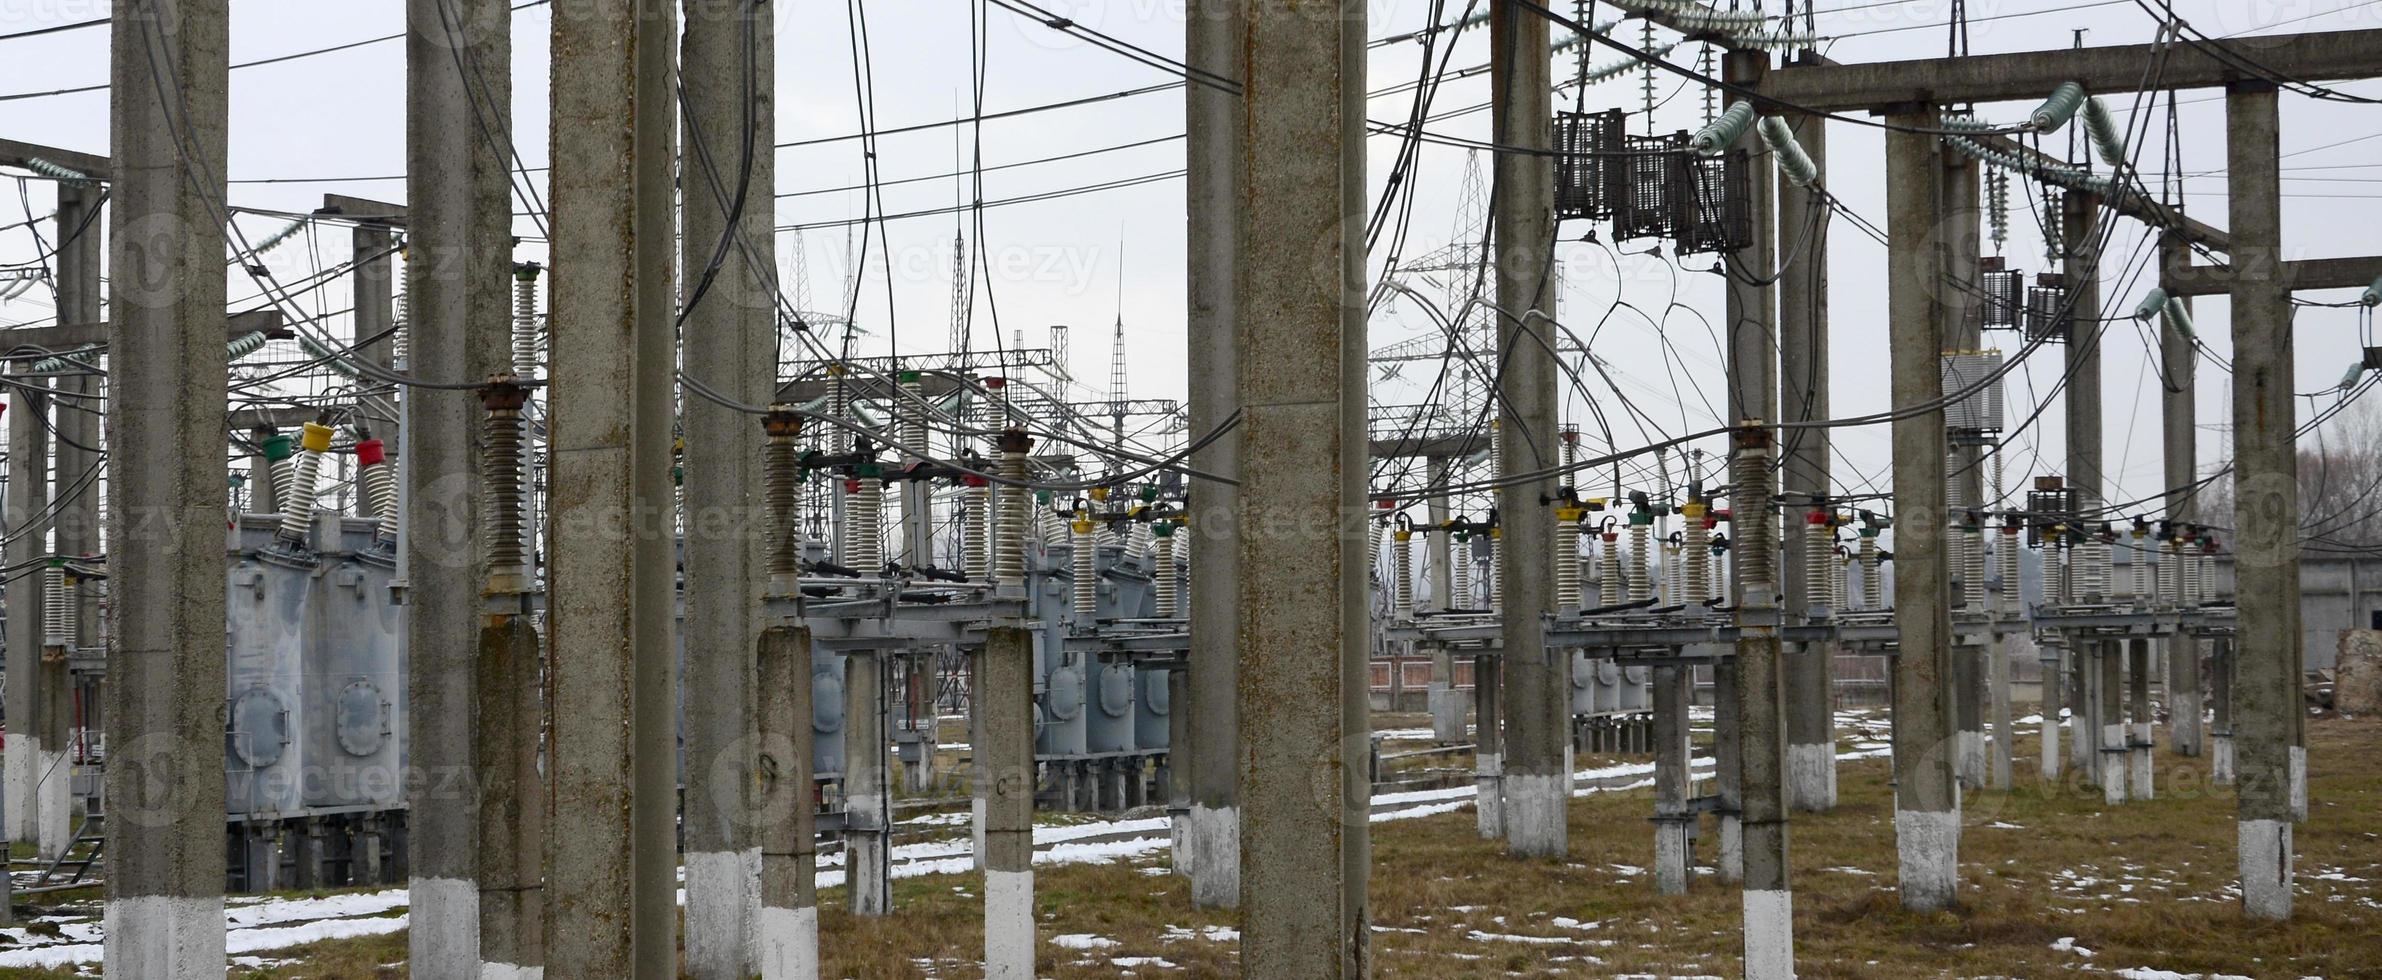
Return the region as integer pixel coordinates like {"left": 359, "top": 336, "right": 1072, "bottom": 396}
{"left": 974, "top": 625, "right": 1036, "bottom": 980}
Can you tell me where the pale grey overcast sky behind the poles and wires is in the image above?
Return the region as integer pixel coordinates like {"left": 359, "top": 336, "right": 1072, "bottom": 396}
{"left": 0, "top": 0, "right": 2382, "bottom": 522}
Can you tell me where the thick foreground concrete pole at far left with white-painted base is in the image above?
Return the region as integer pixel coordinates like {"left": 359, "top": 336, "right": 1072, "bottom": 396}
{"left": 105, "top": 0, "right": 231, "bottom": 980}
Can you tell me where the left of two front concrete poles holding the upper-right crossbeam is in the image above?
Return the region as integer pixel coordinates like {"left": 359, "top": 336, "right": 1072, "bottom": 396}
{"left": 1887, "top": 110, "right": 1960, "bottom": 911}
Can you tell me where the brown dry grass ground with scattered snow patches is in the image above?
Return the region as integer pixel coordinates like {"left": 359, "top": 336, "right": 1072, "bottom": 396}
{"left": 0, "top": 718, "right": 2382, "bottom": 978}
